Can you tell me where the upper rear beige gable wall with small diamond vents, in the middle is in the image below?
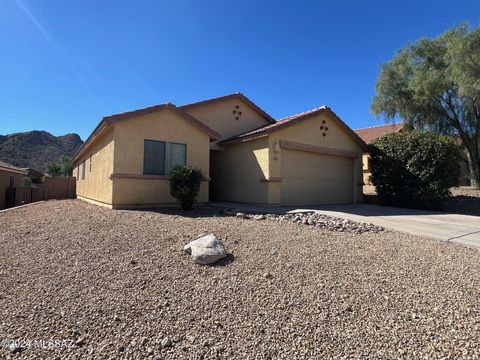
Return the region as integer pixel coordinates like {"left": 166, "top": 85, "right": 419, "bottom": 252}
{"left": 186, "top": 99, "right": 269, "bottom": 141}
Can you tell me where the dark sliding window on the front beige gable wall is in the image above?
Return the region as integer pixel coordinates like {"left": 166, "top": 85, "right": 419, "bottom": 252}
{"left": 143, "top": 140, "right": 187, "bottom": 175}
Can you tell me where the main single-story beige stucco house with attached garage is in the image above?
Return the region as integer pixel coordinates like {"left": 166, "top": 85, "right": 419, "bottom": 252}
{"left": 72, "top": 93, "right": 367, "bottom": 208}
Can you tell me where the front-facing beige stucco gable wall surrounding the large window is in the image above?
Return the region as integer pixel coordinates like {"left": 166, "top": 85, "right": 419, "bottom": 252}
{"left": 113, "top": 111, "right": 210, "bottom": 208}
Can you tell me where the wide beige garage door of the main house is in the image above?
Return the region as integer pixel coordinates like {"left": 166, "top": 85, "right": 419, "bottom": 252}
{"left": 281, "top": 149, "right": 353, "bottom": 205}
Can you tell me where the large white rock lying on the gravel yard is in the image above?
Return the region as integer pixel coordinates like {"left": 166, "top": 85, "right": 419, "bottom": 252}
{"left": 183, "top": 234, "right": 227, "bottom": 265}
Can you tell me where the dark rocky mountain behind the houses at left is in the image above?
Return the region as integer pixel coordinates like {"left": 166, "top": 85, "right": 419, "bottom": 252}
{"left": 0, "top": 130, "right": 83, "bottom": 171}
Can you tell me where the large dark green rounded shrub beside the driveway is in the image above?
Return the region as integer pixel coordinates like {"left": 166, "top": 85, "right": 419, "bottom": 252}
{"left": 370, "top": 131, "right": 460, "bottom": 209}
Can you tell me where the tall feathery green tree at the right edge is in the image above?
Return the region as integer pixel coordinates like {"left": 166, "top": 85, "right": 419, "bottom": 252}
{"left": 371, "top": 24, "right": 480, "bottom": 187}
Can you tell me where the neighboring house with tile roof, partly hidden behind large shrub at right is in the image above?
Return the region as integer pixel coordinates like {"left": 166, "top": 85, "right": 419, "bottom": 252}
{"left": 355, "top": 122, "right": 471, "bottom": 193}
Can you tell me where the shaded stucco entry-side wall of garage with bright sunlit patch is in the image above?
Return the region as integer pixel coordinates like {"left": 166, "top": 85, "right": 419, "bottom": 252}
{"left": 211, "top": 137, "right": 269, "bottom": 204}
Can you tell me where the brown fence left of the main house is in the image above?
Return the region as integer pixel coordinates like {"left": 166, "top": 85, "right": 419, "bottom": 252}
{"left": 6, "top": 176, "right": 77, "bottom": 208}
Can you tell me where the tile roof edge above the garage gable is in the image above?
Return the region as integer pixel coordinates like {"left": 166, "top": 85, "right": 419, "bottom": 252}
{"left": 220, "top": 106, "right": 367, "bottom": 149}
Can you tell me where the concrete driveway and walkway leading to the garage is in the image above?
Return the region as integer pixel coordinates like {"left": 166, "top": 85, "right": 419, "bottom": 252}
{"left": 212, "top": 202, "right": 480, "bottom": 248}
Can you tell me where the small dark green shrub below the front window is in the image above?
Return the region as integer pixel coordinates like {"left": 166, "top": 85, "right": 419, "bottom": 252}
{"left": 170, "top": 166, "right": 203, "bottom": 210}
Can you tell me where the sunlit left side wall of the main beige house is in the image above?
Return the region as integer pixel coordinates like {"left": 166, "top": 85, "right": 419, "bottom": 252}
{"left": 72, "top": 129, "right": 115, "bottom": 206}
